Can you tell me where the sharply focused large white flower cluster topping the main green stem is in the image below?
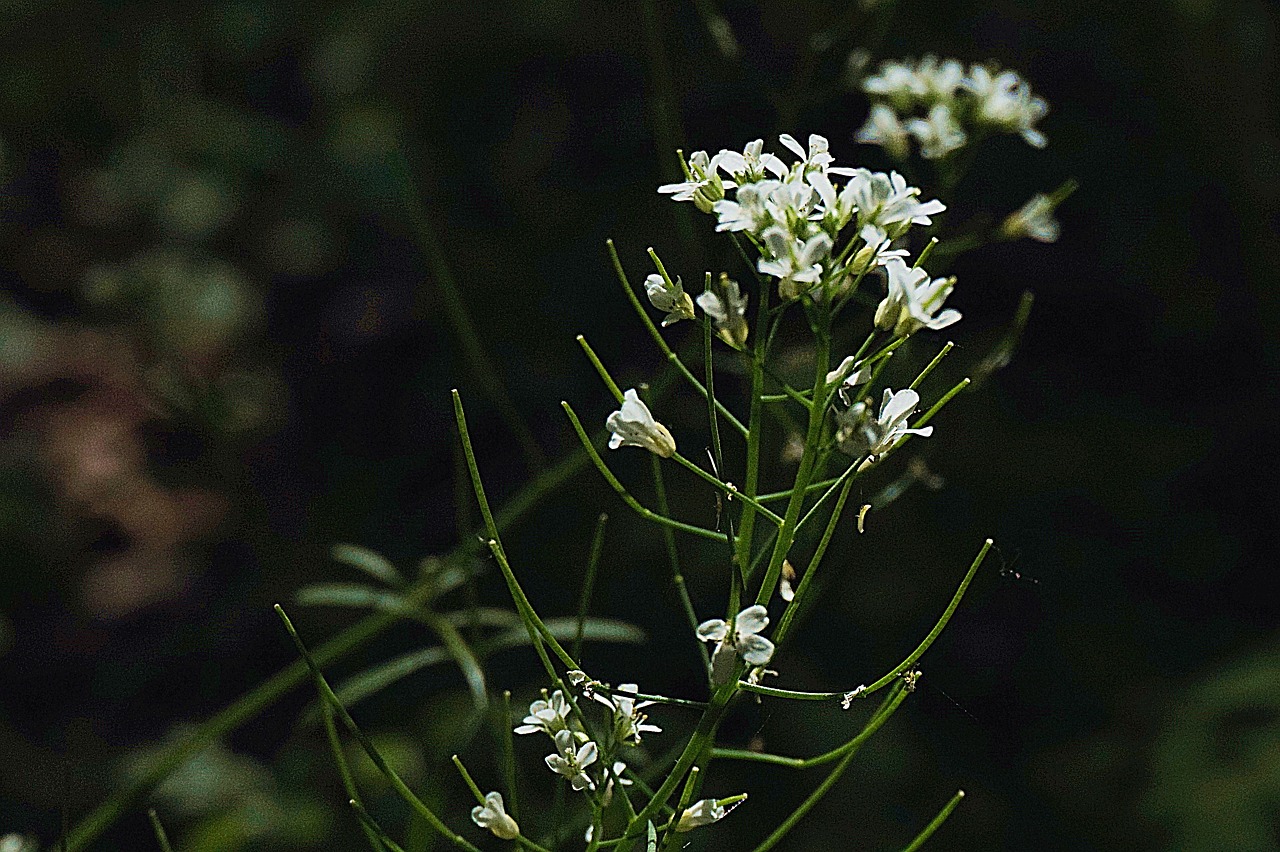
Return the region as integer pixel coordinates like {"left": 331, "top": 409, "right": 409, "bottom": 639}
{"left": 665, "top": 134, "right": 946, "bottom": 300}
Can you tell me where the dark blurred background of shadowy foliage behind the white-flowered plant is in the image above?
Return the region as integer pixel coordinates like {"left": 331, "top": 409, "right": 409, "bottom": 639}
{"left": 0, "top": 0, "right": 1280, "bottom": 852}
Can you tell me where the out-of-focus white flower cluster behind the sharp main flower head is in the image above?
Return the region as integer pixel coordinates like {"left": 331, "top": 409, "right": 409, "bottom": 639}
{"left": 855, "top": 56, "right": 1048, "bottom": 160}
